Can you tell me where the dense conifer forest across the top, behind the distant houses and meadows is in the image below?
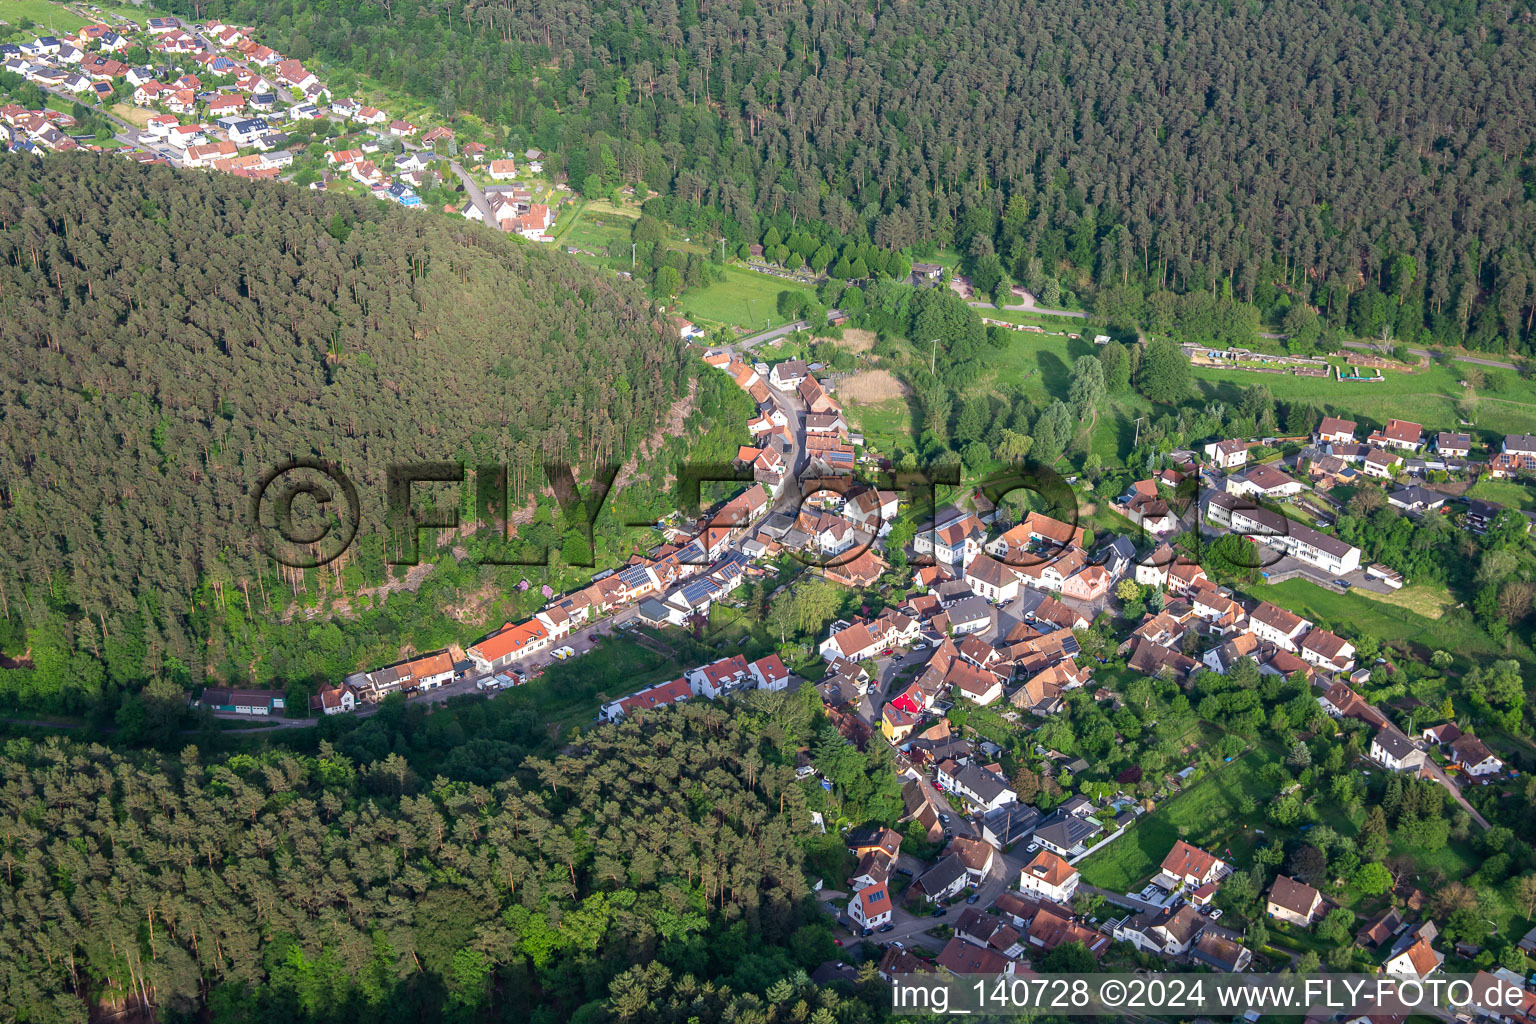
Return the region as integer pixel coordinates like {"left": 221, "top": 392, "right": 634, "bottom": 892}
{"left": 172, "top": 0, "right": 1536, "bottom": 348}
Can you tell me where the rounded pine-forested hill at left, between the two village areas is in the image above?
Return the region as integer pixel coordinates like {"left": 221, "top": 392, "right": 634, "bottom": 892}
{"left": 0, "top": 155, "right": 690, "bottom": 709}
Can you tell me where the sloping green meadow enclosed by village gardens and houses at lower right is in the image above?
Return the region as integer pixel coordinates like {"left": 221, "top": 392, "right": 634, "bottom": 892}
{"left": 1078, "top": 751, "right": 1273, "bottom": 892}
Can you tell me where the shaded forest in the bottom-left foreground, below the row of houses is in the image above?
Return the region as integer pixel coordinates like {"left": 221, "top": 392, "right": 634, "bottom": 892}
{"left": 0, "top": 694, "right": 889, "bottom": 1024}
